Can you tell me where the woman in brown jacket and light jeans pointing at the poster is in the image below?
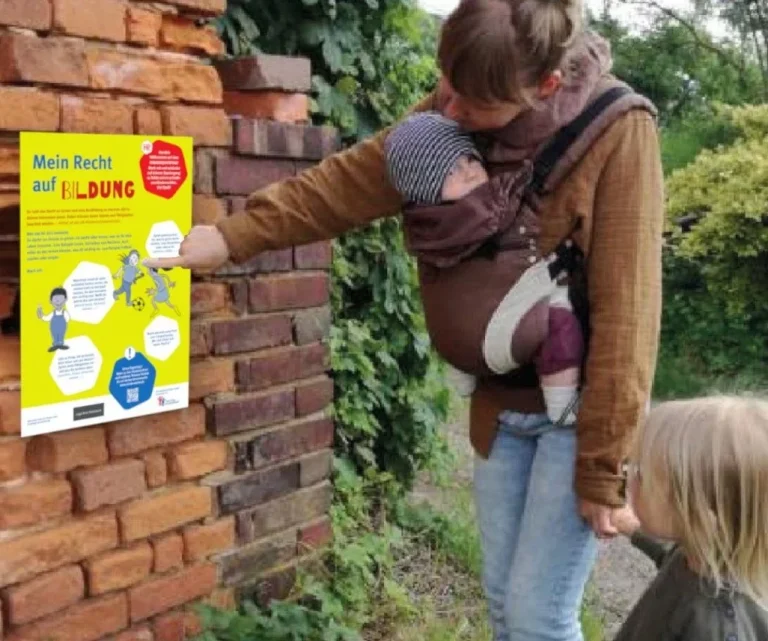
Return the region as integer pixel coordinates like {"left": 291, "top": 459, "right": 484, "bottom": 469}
{"left": 153, "top": 0, "right": 663, "bottom": 641}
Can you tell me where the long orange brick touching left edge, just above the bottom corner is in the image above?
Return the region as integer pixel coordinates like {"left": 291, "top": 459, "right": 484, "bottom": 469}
{"left": 3, "top": 565, "right": 85, "bottom": 625}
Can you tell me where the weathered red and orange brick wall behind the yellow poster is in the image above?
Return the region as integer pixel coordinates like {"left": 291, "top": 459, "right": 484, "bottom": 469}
{"left": 0, "top": 0, "right": 337, "bottom": 641}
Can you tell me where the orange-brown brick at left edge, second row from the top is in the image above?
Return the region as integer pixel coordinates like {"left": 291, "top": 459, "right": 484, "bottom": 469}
{"left": 0, "top": 33, "right": 88, "bottom": 87}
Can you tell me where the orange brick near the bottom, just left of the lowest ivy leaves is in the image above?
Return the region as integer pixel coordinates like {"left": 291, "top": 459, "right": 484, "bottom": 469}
{"left": 128, "top": 564, "right": 217, "bottom": 621}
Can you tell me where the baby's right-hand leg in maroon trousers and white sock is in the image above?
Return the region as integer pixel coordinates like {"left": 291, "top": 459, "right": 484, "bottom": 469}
{"left": 536, "top": 287, "right": 584, "bottom": 425}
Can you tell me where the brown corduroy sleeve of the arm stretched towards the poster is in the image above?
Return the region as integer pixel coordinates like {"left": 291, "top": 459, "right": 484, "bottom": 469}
{"left": 217, "top": 95, "right": 434, "bottom": 262}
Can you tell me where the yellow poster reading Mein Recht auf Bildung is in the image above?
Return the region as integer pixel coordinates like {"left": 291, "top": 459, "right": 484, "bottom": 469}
{"left": 21, "top": 133, "right": 192, "bottom": 436}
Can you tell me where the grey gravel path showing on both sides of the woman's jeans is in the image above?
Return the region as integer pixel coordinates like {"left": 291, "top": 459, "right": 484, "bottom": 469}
{"left": 414, "top": 408, "right": 655, "bottom": 641}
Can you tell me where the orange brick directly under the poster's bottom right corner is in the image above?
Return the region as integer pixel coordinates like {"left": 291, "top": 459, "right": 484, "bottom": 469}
{"left": 107, "top": 404, "right": 205, "bottom": 457}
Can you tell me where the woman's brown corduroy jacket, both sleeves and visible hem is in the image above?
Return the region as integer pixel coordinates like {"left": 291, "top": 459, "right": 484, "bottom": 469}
{"left": 218, "top": 91, "right": 663, "bottom": 506}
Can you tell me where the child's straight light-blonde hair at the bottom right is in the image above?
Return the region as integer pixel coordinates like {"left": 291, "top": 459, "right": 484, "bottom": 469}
{"left": 636, "top": 396, "right": 768, "bottom": 607}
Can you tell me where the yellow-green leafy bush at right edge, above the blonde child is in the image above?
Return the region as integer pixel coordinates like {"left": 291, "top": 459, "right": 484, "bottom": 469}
{"left": 662, "top": 107, "right": 768, "bottom": 381}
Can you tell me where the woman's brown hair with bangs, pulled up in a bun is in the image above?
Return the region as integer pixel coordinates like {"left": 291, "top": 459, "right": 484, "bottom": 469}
{"left": 437, "top": 0, "right": 583, "bottom": 103}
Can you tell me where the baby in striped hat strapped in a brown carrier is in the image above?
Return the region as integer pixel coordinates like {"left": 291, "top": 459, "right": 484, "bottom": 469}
{"left": 385, "top": 112, "right": 585, "bottom": 424}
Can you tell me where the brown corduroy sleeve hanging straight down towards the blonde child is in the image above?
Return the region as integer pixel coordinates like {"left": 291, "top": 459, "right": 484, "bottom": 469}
{"left": 575, "top": 112, "right": 664, "bottom": 506}
